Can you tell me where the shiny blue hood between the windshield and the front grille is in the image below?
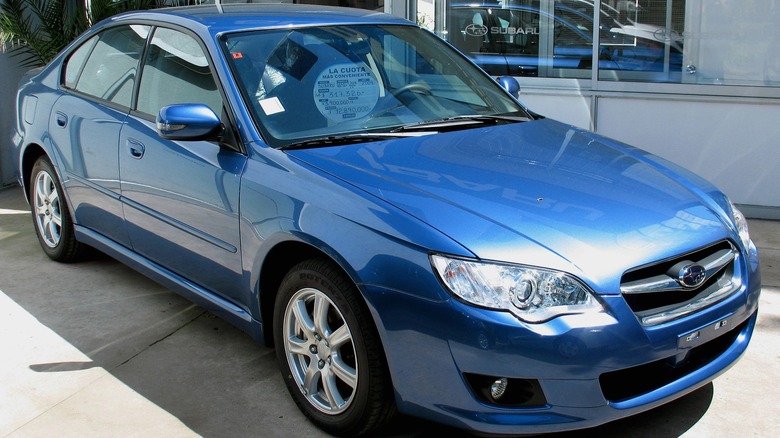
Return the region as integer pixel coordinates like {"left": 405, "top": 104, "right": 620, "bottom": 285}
{"left": 289, "top": 119, "right": 728, "bottom": 288}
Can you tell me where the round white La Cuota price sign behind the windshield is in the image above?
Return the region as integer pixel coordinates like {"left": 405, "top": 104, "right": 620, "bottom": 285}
{"left": 314, "top": 63, "right": 379, "bottom": 122}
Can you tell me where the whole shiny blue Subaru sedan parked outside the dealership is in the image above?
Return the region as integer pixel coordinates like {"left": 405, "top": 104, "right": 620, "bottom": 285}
{"left": 15, "top": 5, "right": 760, "bottom": 436}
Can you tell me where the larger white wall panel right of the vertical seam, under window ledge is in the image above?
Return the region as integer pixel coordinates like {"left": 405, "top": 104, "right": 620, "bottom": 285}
{"left": 597, "top": 98, "right": 780, "bottom": 207}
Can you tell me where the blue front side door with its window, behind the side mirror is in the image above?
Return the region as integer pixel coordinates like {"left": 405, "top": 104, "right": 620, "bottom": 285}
{"left": 119, "top": 28, "right": 246, "bottom": 298}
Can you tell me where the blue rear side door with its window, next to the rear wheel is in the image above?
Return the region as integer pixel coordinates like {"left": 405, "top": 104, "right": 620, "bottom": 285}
{"left": 49, "top": 25, "right": 149, "bottom": 246}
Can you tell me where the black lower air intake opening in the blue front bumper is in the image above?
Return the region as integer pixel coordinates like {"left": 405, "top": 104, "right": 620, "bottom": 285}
{"left": 599, "top": 319, "right": 750, "bottom": 402}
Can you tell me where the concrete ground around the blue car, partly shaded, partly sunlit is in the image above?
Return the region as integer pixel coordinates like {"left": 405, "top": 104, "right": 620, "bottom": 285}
{"left": 0, "top": 187, "right": 780, "bottom": 438}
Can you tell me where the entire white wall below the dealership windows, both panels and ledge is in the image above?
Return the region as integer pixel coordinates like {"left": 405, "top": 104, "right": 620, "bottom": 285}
{"left": 520, "top": 88, "right": 780, "bottom": 219}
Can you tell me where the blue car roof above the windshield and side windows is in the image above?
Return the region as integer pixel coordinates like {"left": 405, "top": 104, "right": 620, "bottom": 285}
{"left": 107, "top": 3, "right": 413, "bottom": 35}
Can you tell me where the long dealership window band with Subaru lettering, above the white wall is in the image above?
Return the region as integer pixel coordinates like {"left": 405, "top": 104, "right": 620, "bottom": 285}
{"left": 430, "top": 0, "right": 780, "bottom": 86}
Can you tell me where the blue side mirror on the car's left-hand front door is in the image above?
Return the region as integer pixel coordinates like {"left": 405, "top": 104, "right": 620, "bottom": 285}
{"left": 157, "top": 103, "right": 222, "bottom": 141}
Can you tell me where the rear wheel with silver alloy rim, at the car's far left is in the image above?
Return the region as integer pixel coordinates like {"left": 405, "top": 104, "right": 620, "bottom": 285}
{"left": 30, "top": 156, "right": 83, "bottom": 262}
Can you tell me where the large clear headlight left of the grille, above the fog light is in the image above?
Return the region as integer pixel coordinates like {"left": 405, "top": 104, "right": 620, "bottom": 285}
{"left": 431, "top": 254, "right": 604, "bottom": 323}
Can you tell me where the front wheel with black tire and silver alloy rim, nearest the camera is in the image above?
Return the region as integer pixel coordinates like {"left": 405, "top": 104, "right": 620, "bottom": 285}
{"left": 274, "top": 259, "right": 395, "bottom": 436}
